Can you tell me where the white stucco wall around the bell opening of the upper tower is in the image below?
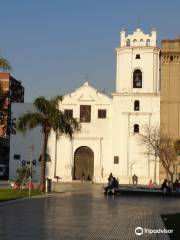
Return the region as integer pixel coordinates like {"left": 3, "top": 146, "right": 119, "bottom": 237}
{"left": 116, "top": 29, "right": 159, "bottom": 93}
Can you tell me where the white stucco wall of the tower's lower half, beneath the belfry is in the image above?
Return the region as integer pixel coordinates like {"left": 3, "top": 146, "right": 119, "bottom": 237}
{"left": 112, "top": 94, "right": 160, "bottom": 184}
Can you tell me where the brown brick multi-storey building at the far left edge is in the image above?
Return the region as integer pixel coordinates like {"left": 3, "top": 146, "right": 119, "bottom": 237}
{"left": 0, "top": 72, "right": 24, "bottom": 178}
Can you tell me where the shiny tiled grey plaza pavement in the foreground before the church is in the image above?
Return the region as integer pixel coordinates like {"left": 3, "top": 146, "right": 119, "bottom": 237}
{"left": 0, "top": 183, "right": 180, "bottom": 240}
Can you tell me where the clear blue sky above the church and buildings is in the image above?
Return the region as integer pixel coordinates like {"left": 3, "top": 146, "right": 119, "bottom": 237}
{"left": 0, "top": 0, "right": 180, "bottom": 102}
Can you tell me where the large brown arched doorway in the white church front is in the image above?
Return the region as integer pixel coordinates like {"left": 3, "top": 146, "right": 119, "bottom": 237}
{"left": 74, "top": 146, "right": 94, "bottom": 180}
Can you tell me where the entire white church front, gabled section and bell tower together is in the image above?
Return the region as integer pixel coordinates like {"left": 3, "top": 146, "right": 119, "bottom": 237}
{"left": 10, "top": 28, "right": 160, "bottom": 184}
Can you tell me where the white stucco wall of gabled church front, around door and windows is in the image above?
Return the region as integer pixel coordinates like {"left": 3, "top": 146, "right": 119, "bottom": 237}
{"left": 45, "top": 82, "right": 112, "bottom": 182}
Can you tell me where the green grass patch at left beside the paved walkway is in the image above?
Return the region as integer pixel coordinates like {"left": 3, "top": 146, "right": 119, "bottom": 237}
{"left": 0, "top": 189, "right": 41, "bottom": 202}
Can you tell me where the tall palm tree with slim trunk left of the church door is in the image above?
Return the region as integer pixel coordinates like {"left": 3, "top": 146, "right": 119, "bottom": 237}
{"left": 17, "top": 96, "right": 80, "bottom": 192}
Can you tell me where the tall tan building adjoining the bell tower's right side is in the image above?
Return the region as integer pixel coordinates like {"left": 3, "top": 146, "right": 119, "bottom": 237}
{"left": 160, "top": 38, "right": 180, "bottom": 178}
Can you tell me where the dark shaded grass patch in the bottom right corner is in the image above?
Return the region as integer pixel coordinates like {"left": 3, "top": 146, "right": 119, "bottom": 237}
{"left": 161, "top": 213, "right": 180, "bottom": 240}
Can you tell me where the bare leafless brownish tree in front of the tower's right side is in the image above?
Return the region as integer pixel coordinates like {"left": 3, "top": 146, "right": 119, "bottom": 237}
{"left": 139, "top": 125, "right": 177, "bottom": 182}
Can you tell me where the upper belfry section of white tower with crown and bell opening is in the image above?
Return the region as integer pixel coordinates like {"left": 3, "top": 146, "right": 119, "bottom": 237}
{"left": 116, "top": 28, "right": 159, "bottom": 94}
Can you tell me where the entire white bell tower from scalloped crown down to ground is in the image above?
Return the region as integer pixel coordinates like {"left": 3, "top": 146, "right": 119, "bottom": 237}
{"left": 112, "top": 28, "right": 160, "bottom": 184}
